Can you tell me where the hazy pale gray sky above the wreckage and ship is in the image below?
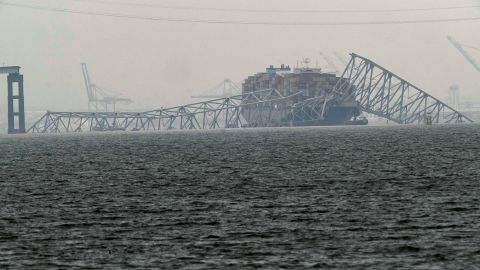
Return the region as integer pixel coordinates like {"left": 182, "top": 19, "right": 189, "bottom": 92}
{"left": 0, "top": 0, "right": 480, "bottom": 118}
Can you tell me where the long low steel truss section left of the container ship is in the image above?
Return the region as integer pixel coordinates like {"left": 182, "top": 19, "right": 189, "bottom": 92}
{"left": 28, "top": 89, "right": 302, "bottom": 133}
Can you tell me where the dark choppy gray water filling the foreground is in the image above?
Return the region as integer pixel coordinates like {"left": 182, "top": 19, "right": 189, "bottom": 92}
{"left": 0, "top": 125, "right": 480, "bottom": 269}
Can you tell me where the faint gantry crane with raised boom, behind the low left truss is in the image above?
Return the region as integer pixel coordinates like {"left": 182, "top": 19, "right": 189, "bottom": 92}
{"left": 81, "top": 63, "right": 132, "bottom": 112}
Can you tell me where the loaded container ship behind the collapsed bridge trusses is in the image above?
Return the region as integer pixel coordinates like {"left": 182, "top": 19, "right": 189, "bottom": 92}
{"left": 242, "top": 65, "right": 368, "bottom": 127}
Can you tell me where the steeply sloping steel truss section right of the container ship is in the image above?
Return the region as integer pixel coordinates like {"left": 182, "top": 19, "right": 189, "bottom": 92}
{"left": 332, "top": 53, "right": 473, "bottom": 124}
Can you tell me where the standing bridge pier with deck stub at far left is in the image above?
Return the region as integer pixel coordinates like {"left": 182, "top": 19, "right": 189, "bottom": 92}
{"left": 0, "top": 66, "right": 25, "bottom": 134}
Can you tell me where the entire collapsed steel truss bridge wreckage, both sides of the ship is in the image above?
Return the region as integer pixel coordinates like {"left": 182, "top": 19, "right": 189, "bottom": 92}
{"left": 28, "top": 54, "right": 472, "bottom": 133}
